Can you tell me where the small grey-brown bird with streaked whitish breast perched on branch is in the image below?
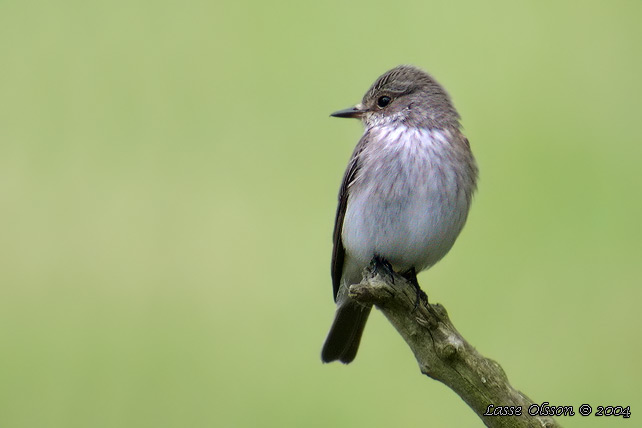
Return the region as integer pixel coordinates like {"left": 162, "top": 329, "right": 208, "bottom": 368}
{"left": 321, "top": 65, "right": 478, "bottom": 364}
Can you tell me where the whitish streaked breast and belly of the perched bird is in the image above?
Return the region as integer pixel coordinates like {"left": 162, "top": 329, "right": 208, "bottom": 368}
{"left": 342, "top": 128, "right": 469, "bottom": 271}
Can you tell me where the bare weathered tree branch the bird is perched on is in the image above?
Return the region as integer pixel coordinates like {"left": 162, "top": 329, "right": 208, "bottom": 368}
{"left": 350, "top": 265, "right": 559, "bottom": 428}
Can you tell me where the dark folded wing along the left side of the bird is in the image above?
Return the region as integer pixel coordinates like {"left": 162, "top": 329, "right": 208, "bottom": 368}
{"left": 332, "top": 134, "right": 367, "bottom": 301}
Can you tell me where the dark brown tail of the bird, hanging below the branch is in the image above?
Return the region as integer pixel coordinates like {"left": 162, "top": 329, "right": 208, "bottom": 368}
{"left": 321, "top": 300, "right": 372, "bottom": 364}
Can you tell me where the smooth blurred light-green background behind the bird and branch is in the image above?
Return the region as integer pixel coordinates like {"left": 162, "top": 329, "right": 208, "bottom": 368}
{"left": 0, "top": 0, "right": 642, "bottom": 428}
